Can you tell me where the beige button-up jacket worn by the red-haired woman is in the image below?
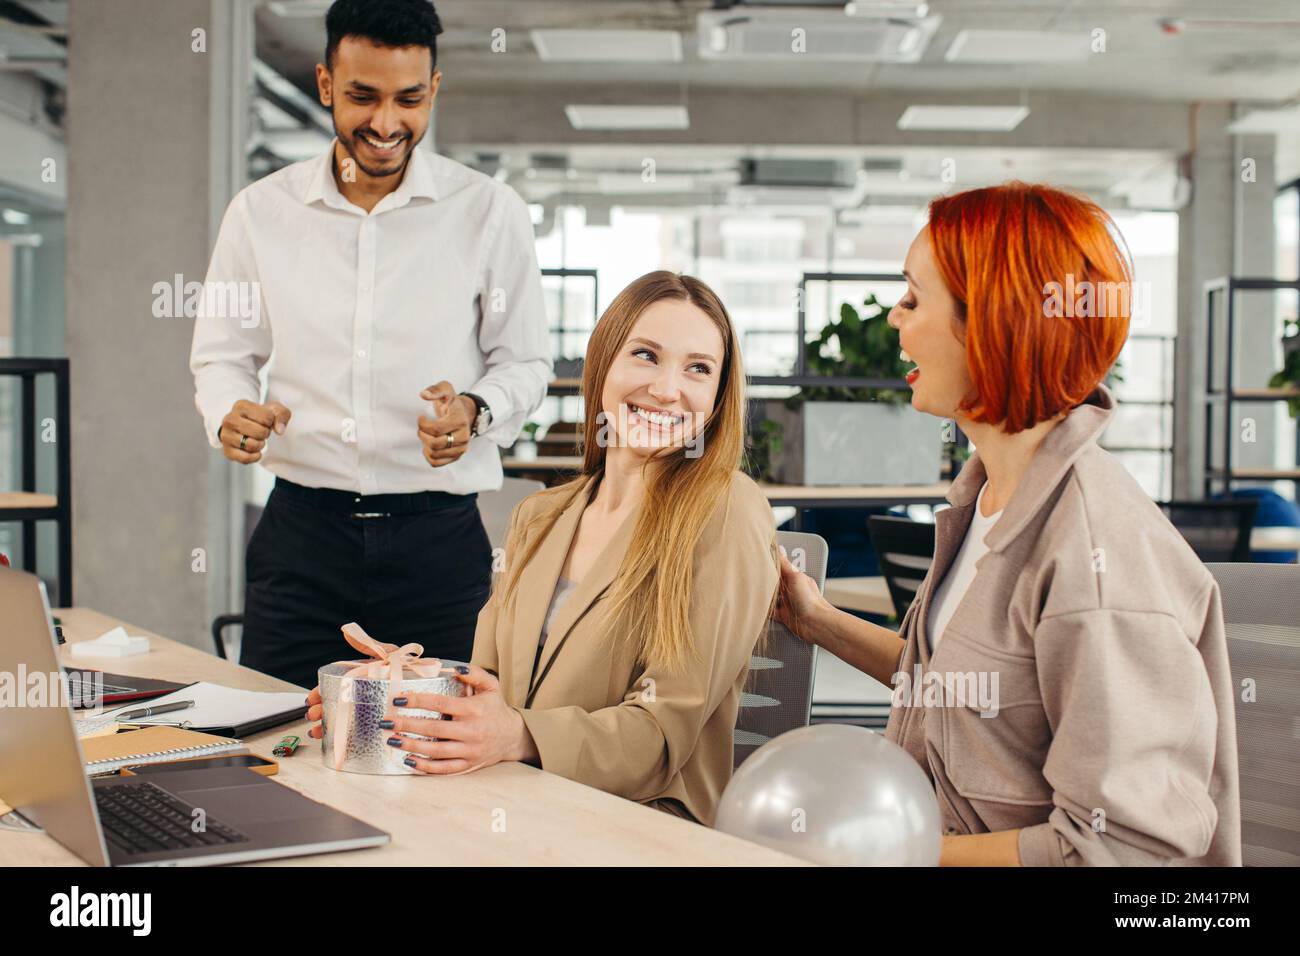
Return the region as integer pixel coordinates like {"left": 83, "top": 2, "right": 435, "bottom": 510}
{"left": 885, "top": 386, "right": 1242, "bottom": 866}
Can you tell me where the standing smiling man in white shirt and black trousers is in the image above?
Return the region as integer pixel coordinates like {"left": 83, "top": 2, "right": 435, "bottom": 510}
{"left": 190, "top": 0, "right": 551, "bottom": 687}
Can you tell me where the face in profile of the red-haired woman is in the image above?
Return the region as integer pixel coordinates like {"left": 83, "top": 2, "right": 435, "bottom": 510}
{"left": 889, "top": 229, "right": 975, "bottom": 419}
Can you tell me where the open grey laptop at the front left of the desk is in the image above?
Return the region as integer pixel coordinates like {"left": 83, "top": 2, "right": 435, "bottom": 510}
{"left": 0, "top": 567, "right": 389, "bottom": 866}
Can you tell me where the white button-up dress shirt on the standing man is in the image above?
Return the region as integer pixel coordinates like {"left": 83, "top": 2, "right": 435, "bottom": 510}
{"left": 190, "top": 143, "right": 551, "bottom": 494}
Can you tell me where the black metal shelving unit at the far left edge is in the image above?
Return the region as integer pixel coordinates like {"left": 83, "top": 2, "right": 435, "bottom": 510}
{"left": 0, "top": 359, "right": 73, "bottom": 607}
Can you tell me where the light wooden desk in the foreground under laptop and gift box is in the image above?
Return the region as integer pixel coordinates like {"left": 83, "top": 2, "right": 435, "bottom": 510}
{"left": 0, "top": 607, "right": 803, "bottom": 866}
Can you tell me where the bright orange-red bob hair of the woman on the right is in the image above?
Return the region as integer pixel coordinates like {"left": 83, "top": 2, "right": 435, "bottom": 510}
{"left": 930, "top": 182, "right": 1132, "bottom": 434}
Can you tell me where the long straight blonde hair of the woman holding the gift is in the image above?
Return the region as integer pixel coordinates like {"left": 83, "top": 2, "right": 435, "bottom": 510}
{"left": 502, "top": 271, "right": 745, "bottom": 669}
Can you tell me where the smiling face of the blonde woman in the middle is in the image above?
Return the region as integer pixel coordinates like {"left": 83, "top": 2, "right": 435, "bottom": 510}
{"left": 601, "top": 299, "right": 723, "bottom": 455}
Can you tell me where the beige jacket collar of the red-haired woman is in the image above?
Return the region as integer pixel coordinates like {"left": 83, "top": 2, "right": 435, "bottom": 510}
{"left": 948, "top": 385, "right": 1115, "bottom": 551}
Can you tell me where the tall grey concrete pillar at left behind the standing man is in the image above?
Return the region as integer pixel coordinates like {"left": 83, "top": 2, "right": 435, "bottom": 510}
{"left": 66, "top": 0, "right": 252, "bottom": 648}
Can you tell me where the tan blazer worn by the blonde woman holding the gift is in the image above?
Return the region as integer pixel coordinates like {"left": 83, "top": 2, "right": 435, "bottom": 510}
{"left": 473, "top": 472, "right": 779, "bottom": 823}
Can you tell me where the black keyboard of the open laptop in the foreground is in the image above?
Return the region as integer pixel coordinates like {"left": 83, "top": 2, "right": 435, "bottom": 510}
{"left": 95, "top": 783, "right": 248, "bottom": 853}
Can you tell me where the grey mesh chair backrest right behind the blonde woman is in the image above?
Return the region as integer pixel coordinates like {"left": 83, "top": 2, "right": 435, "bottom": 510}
{"left": 733, "top": 531, "right": 829, "bottom": 766}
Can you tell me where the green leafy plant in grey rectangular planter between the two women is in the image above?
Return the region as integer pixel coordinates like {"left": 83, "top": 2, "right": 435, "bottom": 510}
{"left": 767, "top": 295, "right": 943, "bottom": 485}
